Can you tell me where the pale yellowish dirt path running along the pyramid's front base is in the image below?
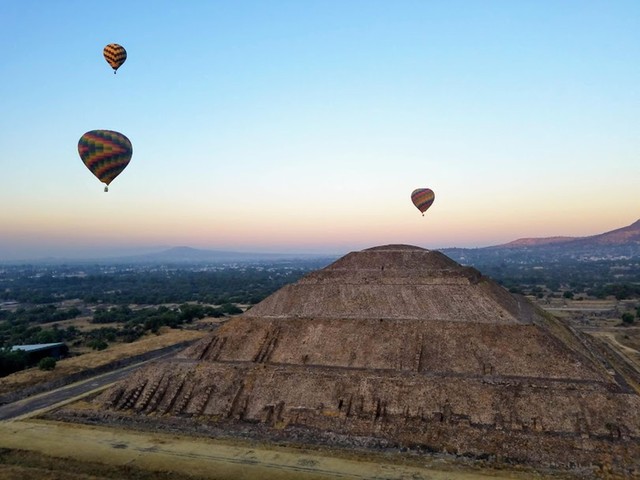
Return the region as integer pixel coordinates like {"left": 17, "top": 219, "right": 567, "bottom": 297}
{"left": 0, "top": 420, "right": 564, "bottom": 480}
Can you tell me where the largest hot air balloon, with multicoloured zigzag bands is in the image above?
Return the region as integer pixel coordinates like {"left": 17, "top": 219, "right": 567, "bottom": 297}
{"left": 78, "top": 130, "right": 133, "bottom": 192}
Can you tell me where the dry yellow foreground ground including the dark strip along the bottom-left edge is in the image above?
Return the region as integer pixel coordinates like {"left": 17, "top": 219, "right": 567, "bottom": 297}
{"left": 0, "top": 421, "right": 579, "bottom": 480}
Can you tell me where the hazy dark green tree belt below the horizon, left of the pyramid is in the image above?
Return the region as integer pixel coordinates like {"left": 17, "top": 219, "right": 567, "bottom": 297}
{"left": 0, "top": 264, "right": 320, "bottom": 305}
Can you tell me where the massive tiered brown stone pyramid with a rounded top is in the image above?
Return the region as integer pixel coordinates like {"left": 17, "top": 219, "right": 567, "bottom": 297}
{"left": 95, "top": 245, "right": 640, "bottom": 471}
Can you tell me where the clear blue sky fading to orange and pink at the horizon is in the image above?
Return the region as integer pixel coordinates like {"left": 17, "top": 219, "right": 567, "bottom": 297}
{"left": 0, "top": 0, "right": 640, "bottom": 260}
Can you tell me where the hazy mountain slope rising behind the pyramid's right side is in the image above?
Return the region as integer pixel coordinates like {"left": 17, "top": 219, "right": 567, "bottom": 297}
{"left": 441, "top": 220, "right": 640, "bottom": 265}
